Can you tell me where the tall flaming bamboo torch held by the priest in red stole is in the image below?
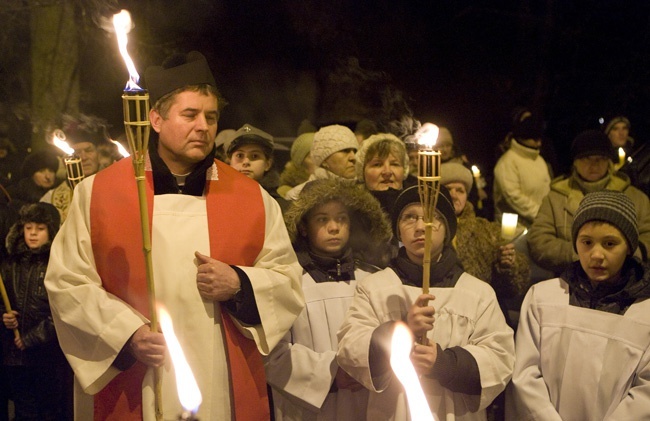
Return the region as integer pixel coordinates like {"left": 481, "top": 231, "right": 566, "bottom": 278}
{"left": 113, "top": 10, "right": 163, "bottom": 420}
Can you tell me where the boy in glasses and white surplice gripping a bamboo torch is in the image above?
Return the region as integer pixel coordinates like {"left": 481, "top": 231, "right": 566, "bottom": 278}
{"left": 337, "top": 186, "right": 514, "bottom": 421}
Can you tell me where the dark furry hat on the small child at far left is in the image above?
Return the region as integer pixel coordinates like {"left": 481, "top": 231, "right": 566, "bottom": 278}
{"left": 5, "top": 202, "right": 61, "bottom": 255}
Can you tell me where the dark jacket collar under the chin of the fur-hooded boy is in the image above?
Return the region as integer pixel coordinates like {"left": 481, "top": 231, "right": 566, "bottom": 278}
{"left": 297, "top": 248, "right": 355, "bottom": 282}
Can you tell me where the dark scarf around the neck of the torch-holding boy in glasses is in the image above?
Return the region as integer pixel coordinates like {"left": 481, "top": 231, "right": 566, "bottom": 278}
{"left": 388, "top": 245, "right": 463, "bottom": 288}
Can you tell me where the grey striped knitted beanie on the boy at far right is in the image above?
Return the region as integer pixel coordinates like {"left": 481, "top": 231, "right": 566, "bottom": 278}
{"left": 571, "top": 190, "right": 639, "bottom": 254}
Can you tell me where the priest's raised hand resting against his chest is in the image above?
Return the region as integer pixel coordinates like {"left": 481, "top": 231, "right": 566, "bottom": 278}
{"left": 194, "top": 251, "right": 241, "bottom": 301}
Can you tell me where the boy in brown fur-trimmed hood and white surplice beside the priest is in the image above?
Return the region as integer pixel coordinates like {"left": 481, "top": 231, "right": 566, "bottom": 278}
{"left": 266, "top": 179, "right": 391, "bottom": 421}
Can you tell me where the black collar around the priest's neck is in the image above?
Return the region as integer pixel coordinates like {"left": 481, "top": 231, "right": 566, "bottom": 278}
{"left": 149, "top": 138, "right": 216, "bottom": 196}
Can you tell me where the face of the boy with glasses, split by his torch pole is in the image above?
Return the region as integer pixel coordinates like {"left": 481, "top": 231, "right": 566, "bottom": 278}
{"left": 397, "top": 203, "right": 446, "bottom": 265}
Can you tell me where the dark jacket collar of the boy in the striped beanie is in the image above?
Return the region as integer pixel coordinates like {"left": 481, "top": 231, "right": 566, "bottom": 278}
{"left": 561, "top": 257, "right": 650, "bottom": 314}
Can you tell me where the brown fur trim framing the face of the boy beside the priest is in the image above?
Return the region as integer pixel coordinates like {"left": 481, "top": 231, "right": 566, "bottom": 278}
{"left": 284, "top": 178, "right": 392, "bottom": 264}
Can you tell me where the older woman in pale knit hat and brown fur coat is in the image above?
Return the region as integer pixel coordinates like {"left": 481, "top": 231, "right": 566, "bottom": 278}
{"left": 440, "top": 162, "right": 530, "bottom": 317}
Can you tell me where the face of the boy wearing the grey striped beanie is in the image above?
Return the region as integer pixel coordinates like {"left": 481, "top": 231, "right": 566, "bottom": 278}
{"left": 576, "top": 221, "right": 628, "bottom": 285}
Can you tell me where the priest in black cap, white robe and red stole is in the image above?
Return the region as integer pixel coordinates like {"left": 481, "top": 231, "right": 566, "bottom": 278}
{"left": 45, "top": 52, "right": 304, "bottom": 420}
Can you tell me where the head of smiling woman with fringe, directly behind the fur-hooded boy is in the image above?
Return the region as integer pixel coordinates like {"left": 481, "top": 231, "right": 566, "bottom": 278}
{"left": 356, "top": 133, "right": 417, "bottom": 213}
